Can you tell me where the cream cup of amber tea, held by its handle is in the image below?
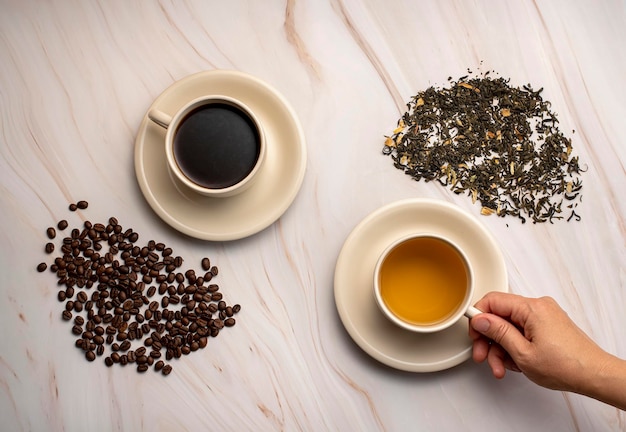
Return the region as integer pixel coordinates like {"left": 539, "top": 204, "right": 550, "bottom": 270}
{"left": 374, "top": 233, "right": 481, "bottom": 333}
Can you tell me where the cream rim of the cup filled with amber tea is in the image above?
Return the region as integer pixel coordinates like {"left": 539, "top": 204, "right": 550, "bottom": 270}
{"left": 374, "top": 232, "right": 472, "bottom": 333}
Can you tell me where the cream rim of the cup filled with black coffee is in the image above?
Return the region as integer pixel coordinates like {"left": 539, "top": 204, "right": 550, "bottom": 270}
{"left": 157, "top": 94, "right": 267, "bottom": 197}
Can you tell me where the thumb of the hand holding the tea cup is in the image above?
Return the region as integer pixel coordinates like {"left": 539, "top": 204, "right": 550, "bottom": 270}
{"left": 470, "top": 313, "right": 530, "bottom": 359}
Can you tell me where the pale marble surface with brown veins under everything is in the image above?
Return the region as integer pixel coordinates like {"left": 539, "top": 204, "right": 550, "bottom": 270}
{"left": 0, "top": 0, "right": 626, "bottom": 431}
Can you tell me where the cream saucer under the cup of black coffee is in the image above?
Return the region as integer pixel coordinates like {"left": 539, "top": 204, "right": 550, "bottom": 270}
{"left": 135, "top": 70, "right": 306, "bottom": 241}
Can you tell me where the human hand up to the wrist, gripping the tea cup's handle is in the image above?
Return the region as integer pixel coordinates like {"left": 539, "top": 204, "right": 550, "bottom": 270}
{"left": 469, "top": 292, "right": 607, "bottom": 393}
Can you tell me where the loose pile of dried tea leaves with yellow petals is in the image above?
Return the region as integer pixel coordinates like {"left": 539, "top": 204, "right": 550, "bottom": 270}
{"left": 383, "top": 73, "right": 582, "bottom": 223}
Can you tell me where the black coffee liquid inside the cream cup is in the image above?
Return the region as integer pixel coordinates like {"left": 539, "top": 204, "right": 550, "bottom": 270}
{"left": 174, "top": 103, "right": 260, "bottom": 189}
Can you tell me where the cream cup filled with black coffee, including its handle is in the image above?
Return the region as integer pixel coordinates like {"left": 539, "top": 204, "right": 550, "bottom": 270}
{"left": 148, "top": 95, "right": 267, "bottom": 197}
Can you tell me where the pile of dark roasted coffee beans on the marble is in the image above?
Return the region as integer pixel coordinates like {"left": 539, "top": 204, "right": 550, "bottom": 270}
{"left": 37, "top": 201, "right": 241, "bottom": 375}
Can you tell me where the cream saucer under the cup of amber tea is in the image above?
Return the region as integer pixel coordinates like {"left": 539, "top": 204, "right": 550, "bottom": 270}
{"left": 335, "top": 199, "right": 508, "bottom": 372}
